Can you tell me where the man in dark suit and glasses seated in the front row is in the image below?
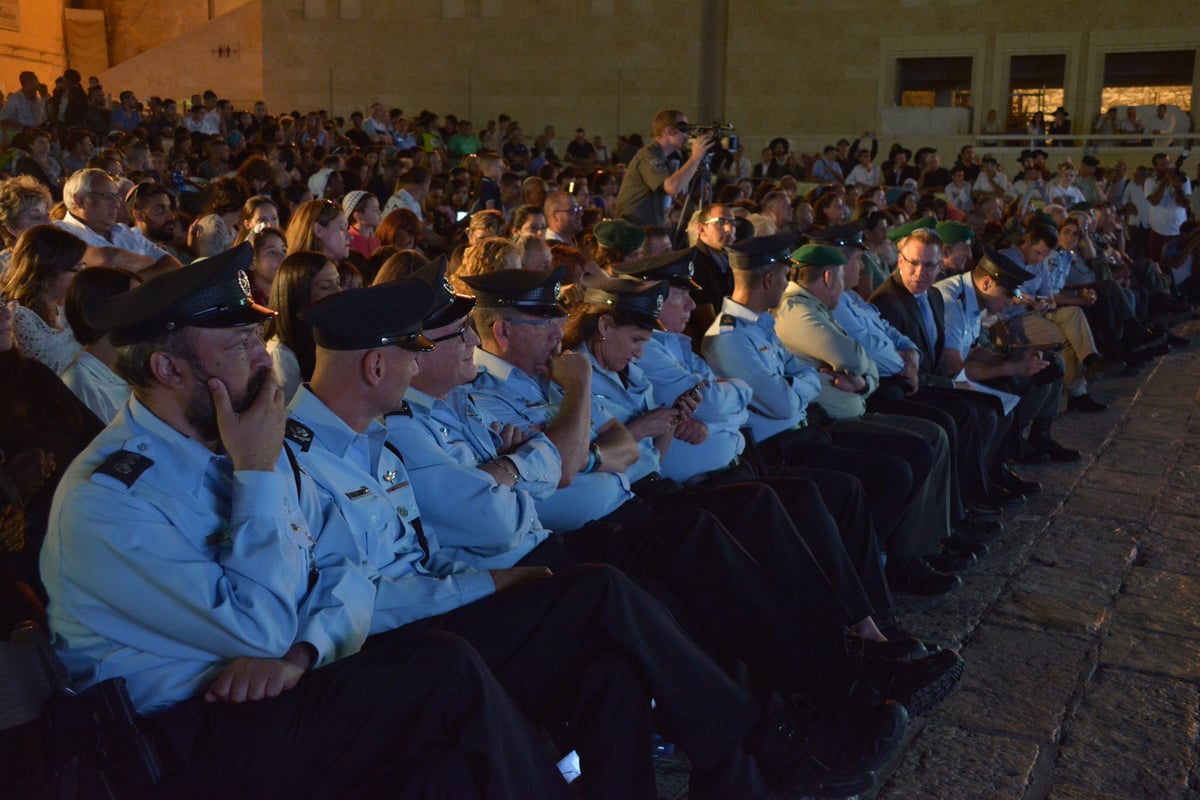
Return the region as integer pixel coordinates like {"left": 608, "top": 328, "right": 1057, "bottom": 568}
{"left": 871, "top": 217, "right": 1042, "bottom": 506}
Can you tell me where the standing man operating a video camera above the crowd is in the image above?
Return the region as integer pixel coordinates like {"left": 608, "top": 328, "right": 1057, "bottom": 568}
{"left": 616, "top": 109, "right": 713, "bottom": 225}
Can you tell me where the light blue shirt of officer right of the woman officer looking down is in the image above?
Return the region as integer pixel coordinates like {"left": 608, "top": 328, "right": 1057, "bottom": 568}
{"left": 637, "top": 331, "right": 750, "bottom": 481}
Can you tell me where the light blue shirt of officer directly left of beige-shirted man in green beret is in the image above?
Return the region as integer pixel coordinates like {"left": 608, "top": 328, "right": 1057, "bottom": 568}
{"left": 703, "top": 297, "right": 821, "bottom": 441}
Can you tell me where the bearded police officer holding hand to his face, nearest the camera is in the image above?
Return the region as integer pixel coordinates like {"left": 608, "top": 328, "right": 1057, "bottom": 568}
{"left": 42, "top": 246, "right": 570, "bottom": 798}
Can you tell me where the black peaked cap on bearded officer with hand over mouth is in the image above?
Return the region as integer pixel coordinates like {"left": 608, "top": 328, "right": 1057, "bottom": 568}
{"left": 84, "top": 243, "right": 275, "bottom": 345}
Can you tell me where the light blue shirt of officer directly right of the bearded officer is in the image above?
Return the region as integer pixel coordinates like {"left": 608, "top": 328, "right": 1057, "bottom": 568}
{"left": 287, "top": 386, "right": 496, "bottom": 633}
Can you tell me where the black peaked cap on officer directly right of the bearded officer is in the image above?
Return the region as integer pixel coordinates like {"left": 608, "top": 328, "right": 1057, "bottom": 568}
{"left": 300, "top": 278, "right": 434, "bottom": 351}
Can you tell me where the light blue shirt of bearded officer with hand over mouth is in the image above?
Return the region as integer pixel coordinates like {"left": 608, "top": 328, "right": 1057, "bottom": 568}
{"left": 41, "top": 398, "right": 374, "bottom": 714}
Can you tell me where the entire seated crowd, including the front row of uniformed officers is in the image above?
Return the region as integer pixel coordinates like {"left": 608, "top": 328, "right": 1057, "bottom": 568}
{"left": 0, "top": 71, "right": 1200, "bottom": 800}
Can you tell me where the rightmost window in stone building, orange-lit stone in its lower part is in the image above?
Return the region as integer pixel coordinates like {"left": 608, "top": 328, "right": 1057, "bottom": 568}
{"left": 1100, "top": 50, "right": 1195, "bottom": 112}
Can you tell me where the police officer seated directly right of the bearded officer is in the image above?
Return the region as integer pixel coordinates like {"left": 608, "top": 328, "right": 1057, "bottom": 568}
{"left": 287, "top": 272, "right": 802, "bottom": 798}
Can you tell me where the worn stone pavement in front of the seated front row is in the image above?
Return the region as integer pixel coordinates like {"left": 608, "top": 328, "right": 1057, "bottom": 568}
{"left": 865, "top": 323, "right": 1200, "bottom": 800}
